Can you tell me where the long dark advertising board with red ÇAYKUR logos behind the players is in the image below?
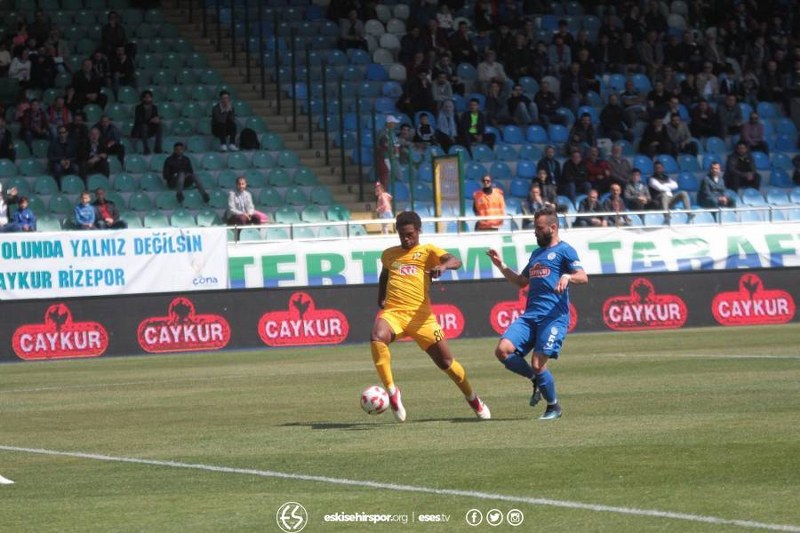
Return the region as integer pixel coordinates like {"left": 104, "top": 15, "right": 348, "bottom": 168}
{"left": 0, "top": 267, "right": 800, "bottom": 361}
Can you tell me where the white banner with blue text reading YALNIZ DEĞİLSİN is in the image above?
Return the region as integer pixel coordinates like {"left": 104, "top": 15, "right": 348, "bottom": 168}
{"left": 0, "top": 228, "right": 228, "bottom": 300}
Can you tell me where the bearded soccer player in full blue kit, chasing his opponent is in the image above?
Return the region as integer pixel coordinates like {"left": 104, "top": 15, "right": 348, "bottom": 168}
{"left": 486, "top": 207, "right": 589, "bottom": 420}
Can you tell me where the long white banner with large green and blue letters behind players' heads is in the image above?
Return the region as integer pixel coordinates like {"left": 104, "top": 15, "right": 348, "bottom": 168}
{"left": 228, "top": 223, "right": 800, "bottom": 289}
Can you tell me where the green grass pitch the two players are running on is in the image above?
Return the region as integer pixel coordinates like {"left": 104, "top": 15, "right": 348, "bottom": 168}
{"left": 0, "top": 324, "right": 800, "bottom": 532}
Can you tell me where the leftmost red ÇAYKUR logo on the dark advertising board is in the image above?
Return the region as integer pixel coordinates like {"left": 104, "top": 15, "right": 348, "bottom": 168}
{"left": 11, "top": 304, "right": 108, "bottom": 360}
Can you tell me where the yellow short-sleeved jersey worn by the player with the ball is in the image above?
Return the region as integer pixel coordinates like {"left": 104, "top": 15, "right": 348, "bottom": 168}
{"left": 381, "top": 244, "right": 447, "bottom": 311}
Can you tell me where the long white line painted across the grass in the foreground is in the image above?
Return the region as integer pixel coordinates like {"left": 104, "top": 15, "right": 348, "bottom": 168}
{"left": 0, "top": 445, "right": 800, "bottom": 533}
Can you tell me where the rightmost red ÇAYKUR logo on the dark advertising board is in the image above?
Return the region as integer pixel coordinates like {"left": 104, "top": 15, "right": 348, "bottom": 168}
{"left": 711, "top": 274, "right": 795, "bottom": 326}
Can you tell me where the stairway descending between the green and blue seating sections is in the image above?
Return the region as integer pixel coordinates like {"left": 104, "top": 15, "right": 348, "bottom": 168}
{"left": 161, "top": 1, "right": 380, "bottom": 227}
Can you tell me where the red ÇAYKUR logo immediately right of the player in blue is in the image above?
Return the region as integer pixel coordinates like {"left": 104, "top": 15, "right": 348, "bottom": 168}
{"left": 603, "top": 278, "right": 687, "bottom": 331}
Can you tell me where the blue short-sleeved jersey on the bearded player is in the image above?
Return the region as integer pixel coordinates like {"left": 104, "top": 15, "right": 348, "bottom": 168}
{"left": 520, "top": 241, "right": 583, "bottom": 319}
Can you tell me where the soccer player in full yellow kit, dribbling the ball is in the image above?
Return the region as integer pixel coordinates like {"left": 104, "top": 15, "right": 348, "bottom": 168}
{"left": 371, "top": 211, "right": 492, "bottom": 422}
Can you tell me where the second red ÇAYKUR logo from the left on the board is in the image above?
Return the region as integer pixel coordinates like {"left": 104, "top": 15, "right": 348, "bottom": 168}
{"left": 136, "top": 296, "right": 231, "bottom": 353}
